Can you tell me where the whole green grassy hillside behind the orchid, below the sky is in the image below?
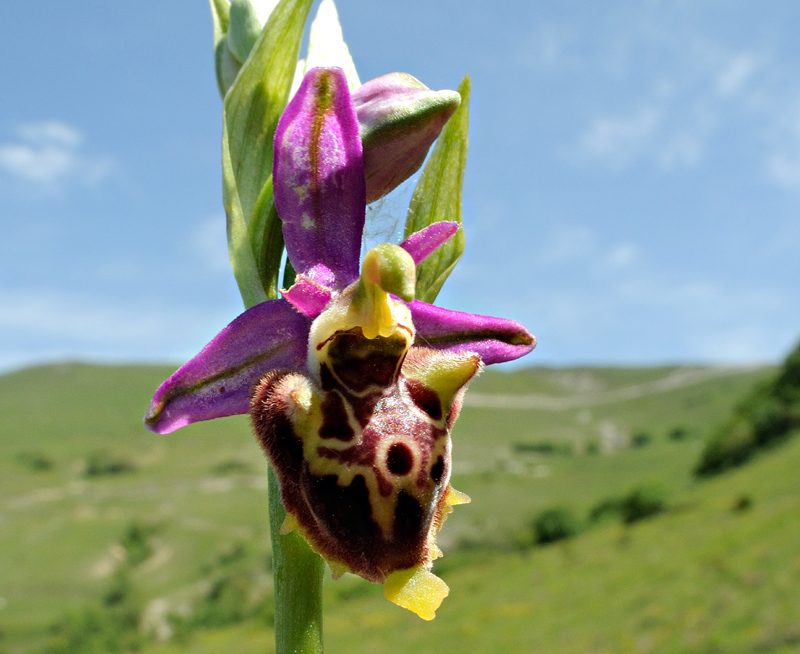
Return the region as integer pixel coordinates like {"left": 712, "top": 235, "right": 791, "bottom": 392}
{"left": 0, "top": 364, "right": 800, "bottom": 654}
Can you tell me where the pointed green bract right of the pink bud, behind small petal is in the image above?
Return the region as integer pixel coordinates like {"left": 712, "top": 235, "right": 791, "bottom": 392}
{"left": 405, "top": 75, "right": 470, "bottom": 303}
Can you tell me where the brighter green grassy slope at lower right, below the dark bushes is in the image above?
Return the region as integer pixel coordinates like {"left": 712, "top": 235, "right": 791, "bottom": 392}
{"left": 318, "top": 441, "right": 800, "bottom": 654}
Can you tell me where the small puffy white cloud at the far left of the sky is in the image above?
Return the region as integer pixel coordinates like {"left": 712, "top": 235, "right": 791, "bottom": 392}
{"left": 0, "top": 121, "right": 113, "bottom": 191}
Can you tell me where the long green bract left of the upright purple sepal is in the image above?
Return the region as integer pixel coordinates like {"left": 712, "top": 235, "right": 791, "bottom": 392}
{"left": 223, "top": 0, "right": 312, "bottom": 306}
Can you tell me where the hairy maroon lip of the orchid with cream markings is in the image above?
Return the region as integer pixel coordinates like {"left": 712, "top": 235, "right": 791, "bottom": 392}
{"left": 251, "top": 282, "right": 482, "bottom": 617}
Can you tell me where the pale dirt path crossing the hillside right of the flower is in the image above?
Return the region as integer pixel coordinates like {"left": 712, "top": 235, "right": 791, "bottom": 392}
{"left": 464, "top": 366, "right": 762, "bottom": 411}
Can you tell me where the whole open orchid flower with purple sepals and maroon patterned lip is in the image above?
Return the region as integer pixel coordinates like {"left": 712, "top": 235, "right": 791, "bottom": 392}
{"left": 145, "top": 68, "right": 535, "bottom": 619}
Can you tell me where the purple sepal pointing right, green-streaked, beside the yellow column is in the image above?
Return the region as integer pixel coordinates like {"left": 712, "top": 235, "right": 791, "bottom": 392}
{"left": 408, "top": 300, "right": 536, "bottom": 364}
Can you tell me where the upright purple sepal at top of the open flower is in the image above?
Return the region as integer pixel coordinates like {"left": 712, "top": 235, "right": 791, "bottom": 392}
{"left": 273, "top": 68, "right": 366, "bottom": 288}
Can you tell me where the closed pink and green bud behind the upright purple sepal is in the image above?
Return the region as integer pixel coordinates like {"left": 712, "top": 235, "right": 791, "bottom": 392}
{"left": 353, "top": 73, "right": 461, "bottom": 202}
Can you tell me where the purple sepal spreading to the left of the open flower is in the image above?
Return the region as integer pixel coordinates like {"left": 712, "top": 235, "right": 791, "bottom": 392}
{"left": 144, "top": 300, "right": 311, "bottom": 434}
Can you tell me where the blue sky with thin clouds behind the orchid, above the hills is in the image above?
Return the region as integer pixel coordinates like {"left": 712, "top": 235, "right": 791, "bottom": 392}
{"left": 0, "top": 0, "right": 800, "bottom": 370}
